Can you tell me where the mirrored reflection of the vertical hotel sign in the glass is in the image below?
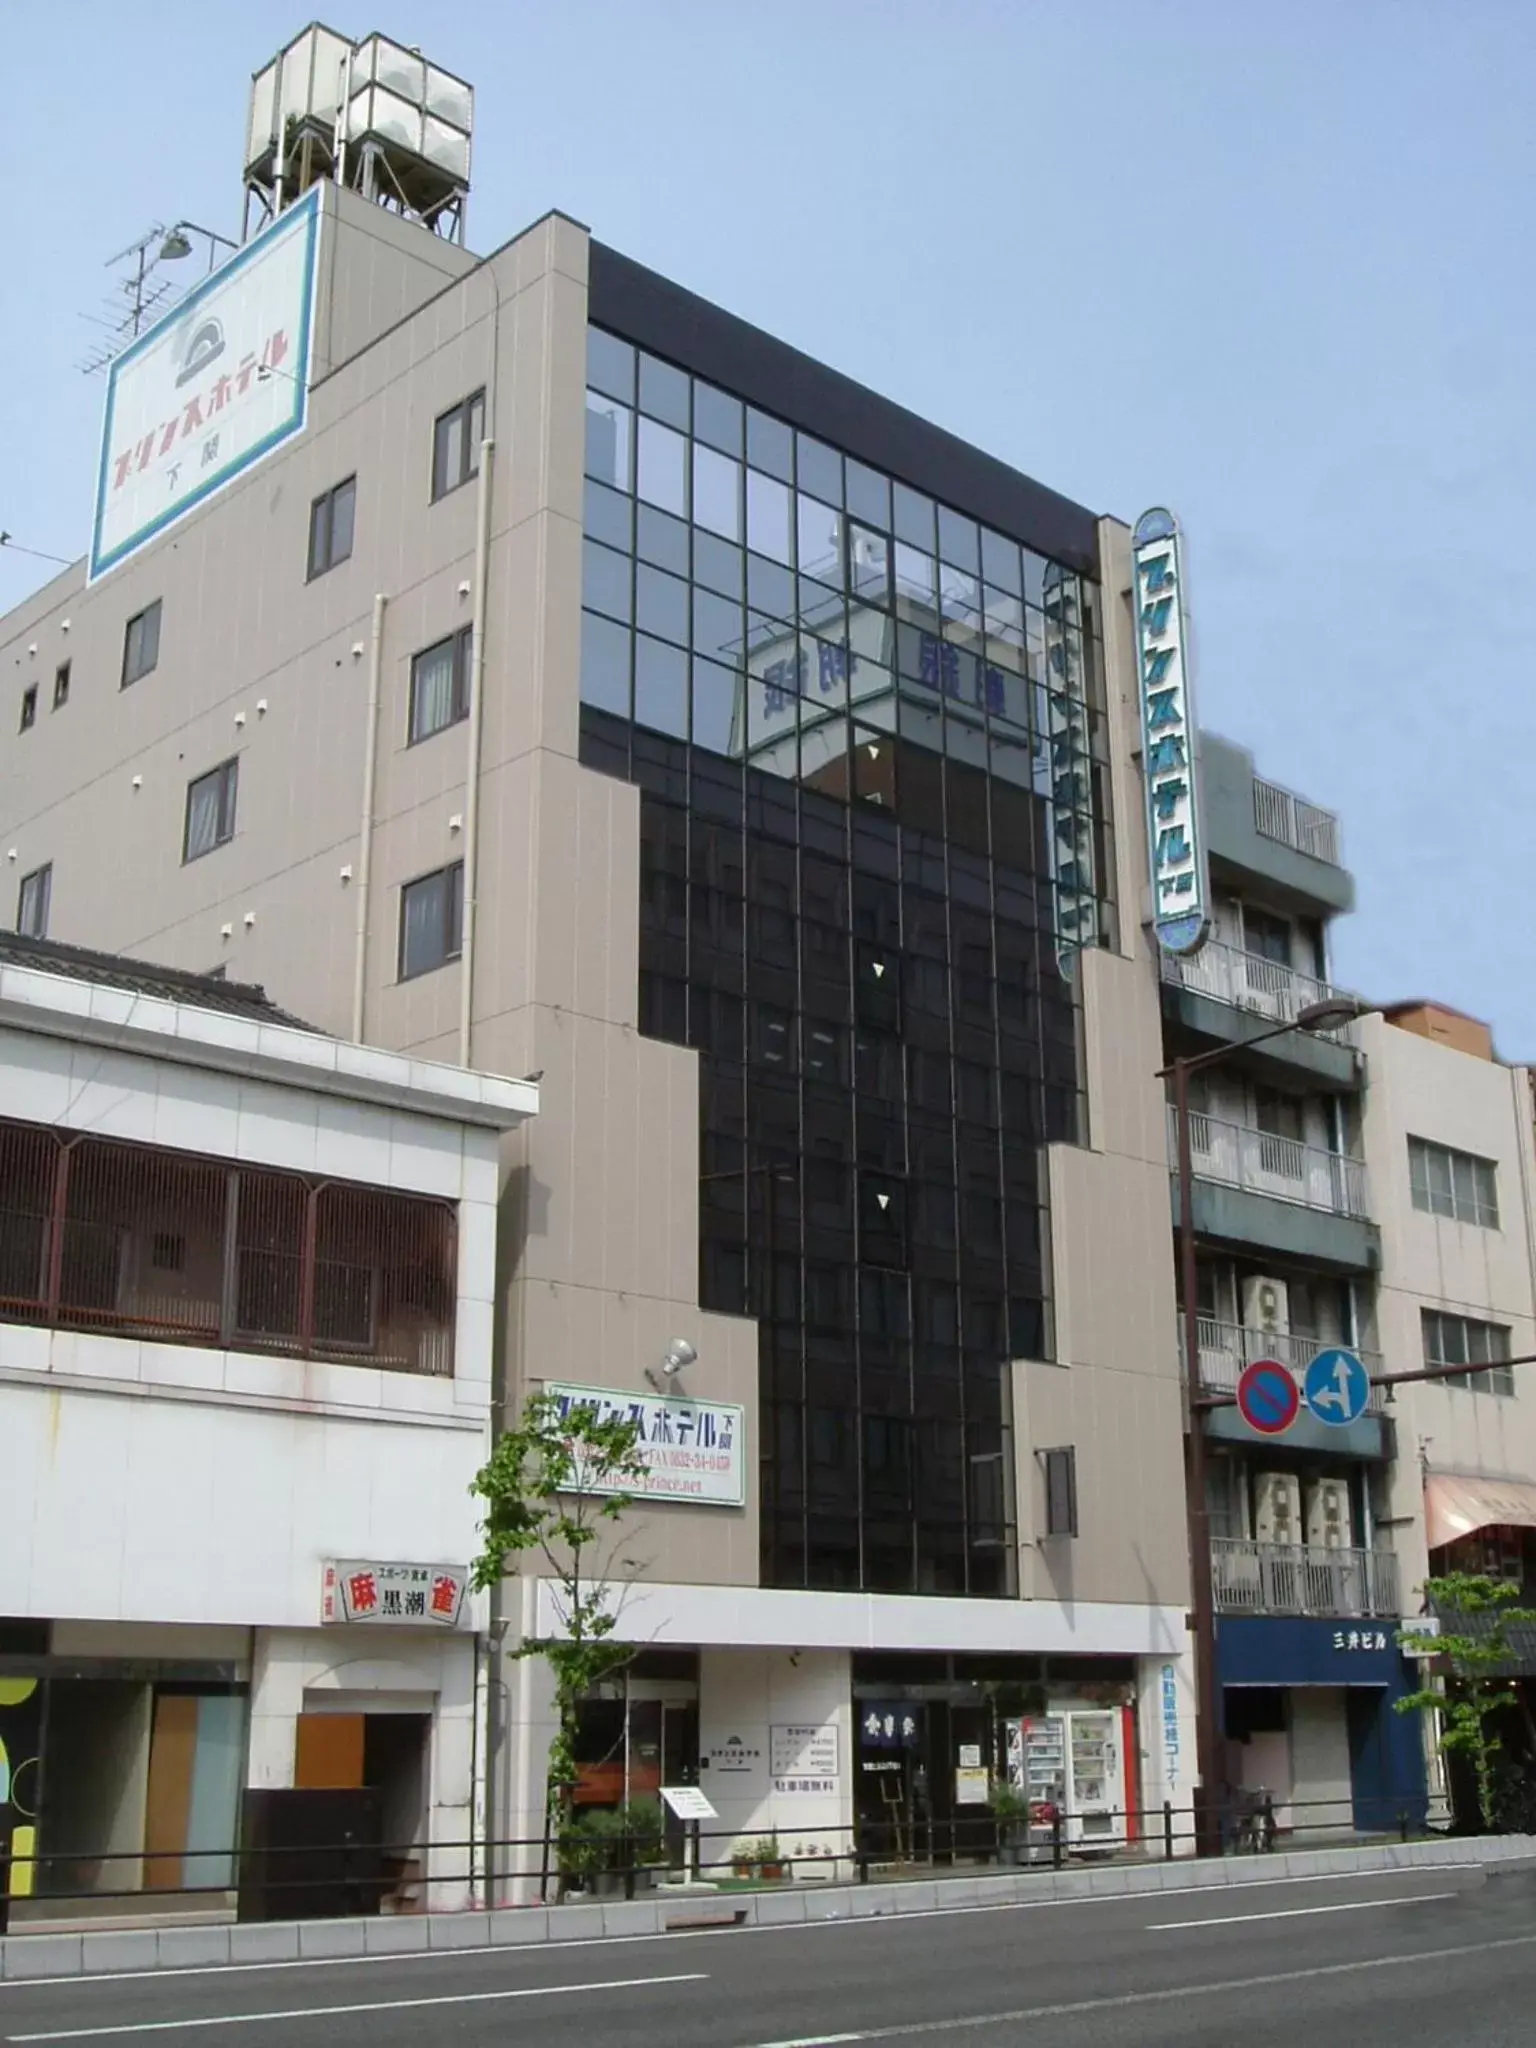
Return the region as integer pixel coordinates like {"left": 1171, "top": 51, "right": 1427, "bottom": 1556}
{"left": 1042, "top": 561, "right": 1098, "bottom": 979}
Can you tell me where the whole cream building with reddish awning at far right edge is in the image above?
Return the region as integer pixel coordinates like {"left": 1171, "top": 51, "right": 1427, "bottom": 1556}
{"left": 1362, "top": 1004, "right": 1536, "bottom": 1818}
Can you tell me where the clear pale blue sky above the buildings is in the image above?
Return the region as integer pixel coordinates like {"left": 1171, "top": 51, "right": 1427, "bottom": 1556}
{"left": 0, "top": 0, "right": 1536, "bottom": 1040}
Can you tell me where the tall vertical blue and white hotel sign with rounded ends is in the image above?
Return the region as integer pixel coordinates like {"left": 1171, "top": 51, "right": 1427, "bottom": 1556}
{"left": 1130, "top": 506, "right": 1210, "bottom": 952}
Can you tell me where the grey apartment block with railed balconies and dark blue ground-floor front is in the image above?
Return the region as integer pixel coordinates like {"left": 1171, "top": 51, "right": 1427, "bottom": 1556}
{"left": 1161, "top": 735, "right": 1433, "bottom": 1829}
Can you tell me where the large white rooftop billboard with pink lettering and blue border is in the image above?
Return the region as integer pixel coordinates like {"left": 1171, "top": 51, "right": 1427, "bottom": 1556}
{"left": 90, "top": 186, "right": 319, "bottom": 580}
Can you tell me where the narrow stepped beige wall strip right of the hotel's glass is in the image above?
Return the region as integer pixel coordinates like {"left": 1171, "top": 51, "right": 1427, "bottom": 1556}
{"left": 1014, "top": 520, "right": 1190, "bottom": 1606}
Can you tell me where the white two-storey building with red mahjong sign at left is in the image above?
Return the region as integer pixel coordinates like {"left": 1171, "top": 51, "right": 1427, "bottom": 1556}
{"left": 0, "top": 934, "right": 537, "bottom": 1917}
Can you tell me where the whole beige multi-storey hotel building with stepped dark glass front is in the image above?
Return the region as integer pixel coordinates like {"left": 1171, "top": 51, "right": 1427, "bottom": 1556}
{"left": 0, "top": 24, "right": 1196, "bottom": 1853}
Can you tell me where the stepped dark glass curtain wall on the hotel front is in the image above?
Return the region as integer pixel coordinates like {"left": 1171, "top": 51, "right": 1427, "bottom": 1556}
{"left": 582, "top": 328, "right": 1112, "bottom": 1595}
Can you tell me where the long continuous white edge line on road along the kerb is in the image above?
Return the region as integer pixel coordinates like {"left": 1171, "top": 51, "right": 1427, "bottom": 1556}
{"left": 0, "top": 1864, "right": 1489, "bottom": 1999}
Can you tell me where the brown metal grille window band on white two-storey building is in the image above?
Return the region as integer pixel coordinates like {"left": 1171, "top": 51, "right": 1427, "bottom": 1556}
{"left": 0, "top": 1122, "right": 457, "bottom": 1376}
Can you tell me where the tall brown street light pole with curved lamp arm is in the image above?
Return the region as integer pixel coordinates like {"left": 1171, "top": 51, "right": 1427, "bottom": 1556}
{"left": 1157, "top": 995, "right": 1374, "bottom": 1855}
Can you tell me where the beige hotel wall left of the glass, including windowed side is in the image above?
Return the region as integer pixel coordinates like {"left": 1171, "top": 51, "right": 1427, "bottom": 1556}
{"left": 0, "top": 195, "right": 758, "bottom": 1583}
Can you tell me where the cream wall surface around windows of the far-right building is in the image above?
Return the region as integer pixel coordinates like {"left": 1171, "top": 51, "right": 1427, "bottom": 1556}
{"left": 1362, "top": 1018, "right": 1536, "bottom": 1612}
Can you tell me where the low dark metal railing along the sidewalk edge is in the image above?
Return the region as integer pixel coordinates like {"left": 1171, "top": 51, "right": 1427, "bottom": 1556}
{"left": 0, "top": 1788, "right": 1430, "bottom": 1933}
